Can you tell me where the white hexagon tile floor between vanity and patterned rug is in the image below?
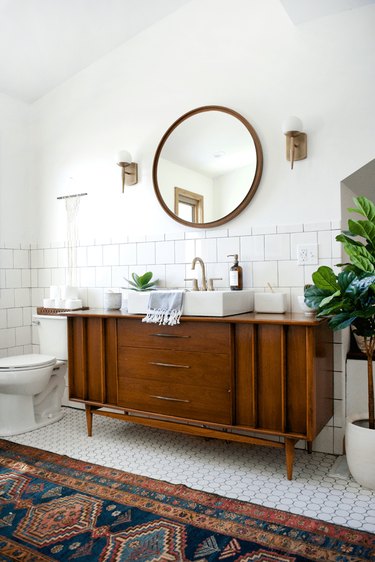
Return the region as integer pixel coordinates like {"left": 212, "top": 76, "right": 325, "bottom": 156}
{"left": 5, "top": 408, "right": 375, "bottom": 533}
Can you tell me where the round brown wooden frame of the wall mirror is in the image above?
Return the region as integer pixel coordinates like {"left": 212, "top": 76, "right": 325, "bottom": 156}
{"left": 152, "top": 105, "right": 263, "bottom": 228}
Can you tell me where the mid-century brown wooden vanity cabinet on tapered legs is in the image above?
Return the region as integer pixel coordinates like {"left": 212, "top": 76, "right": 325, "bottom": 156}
{"left": 68, "top": 310, "right": 333, "bottom": 479}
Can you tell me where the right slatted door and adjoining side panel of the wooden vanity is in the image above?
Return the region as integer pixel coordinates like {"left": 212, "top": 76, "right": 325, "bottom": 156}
{"left": 235, "top": 324, "right": 333, "bottom": 440}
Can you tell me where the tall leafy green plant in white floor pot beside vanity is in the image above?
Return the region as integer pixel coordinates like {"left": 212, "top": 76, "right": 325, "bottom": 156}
{"left": 304, "top": 197, "right": 375, "bottom": 489}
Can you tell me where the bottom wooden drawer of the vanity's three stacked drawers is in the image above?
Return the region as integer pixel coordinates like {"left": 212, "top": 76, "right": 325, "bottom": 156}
{"left": 118, "top": 378, "right": 232, "bottom": 424}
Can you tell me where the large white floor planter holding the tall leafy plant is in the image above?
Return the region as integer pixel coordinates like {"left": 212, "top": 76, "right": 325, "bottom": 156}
{"left": 345, "top": 414, "right": 375, "bottom": 490}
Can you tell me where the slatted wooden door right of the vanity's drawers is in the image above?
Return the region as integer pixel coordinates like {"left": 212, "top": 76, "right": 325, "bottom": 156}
{"left": 236, "top": 324, "right": 314, "bottom": 435}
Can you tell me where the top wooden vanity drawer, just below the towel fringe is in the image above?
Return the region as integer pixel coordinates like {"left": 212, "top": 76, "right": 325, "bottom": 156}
{"left": 118, "top": 318, "right": 232, "bottom": 353}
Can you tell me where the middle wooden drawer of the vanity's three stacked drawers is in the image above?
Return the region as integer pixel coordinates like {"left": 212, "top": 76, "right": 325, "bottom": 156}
{"left": 118, "top": 347, "right": 231, "bottom": 390}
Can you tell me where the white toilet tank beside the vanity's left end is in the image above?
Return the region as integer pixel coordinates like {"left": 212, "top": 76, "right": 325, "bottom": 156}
{"left": 33, "top": 314, "right": 68, "bottom": 361}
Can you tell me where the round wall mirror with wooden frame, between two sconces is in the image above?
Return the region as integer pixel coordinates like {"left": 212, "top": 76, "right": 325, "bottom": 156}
{"left": 152, "top": 105, "right": 263, "bottom": 228}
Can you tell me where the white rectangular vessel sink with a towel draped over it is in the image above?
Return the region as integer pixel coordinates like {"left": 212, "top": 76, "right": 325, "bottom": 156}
{"left": 128, "top": 290, "right": 254, "bottom": 316}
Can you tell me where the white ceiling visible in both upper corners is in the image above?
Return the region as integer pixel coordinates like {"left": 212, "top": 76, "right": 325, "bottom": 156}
{"left": 0, "top": 0, "right": 375, "bottom": 103}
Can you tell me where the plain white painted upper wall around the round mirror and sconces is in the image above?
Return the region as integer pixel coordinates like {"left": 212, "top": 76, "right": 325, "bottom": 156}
{"left": 28, "top": 0, "right": 375, "bottom": 244}
